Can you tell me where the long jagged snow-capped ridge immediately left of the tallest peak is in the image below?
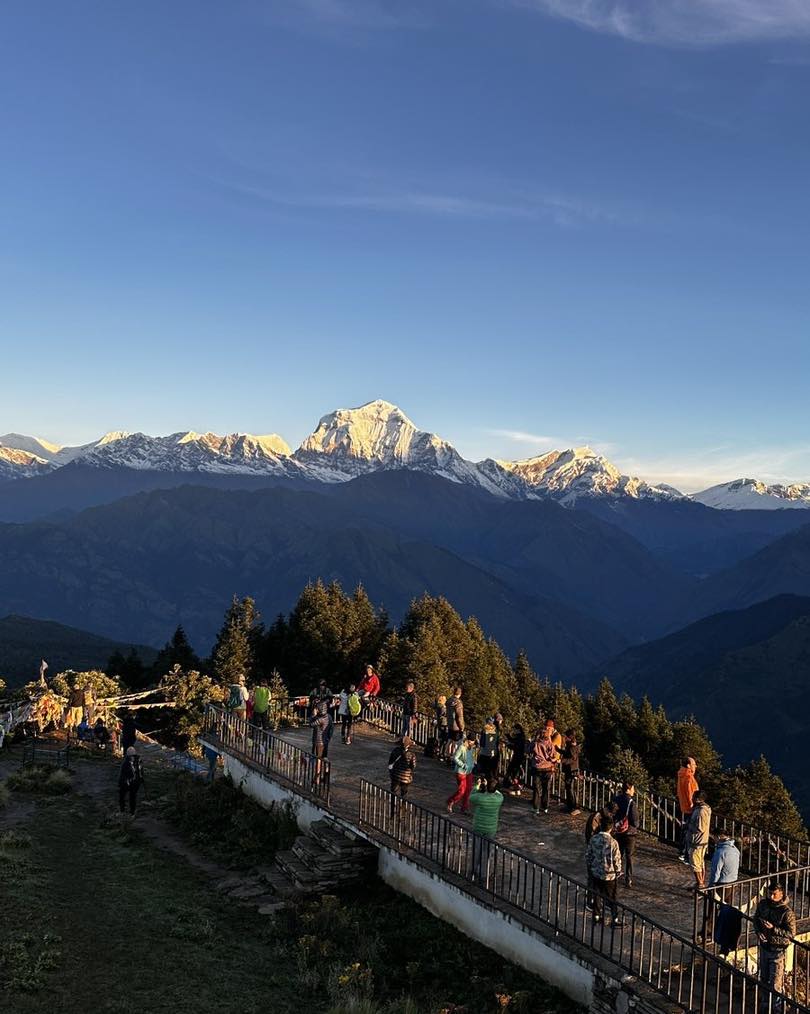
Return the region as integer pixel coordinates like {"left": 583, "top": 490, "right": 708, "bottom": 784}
{"left": 74, "top": 431, "right": 295, "bottom": 475}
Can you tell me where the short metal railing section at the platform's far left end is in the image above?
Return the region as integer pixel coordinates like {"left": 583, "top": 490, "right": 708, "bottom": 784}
{"left": 203, "top": 704, "right": 330, "bottom": 804}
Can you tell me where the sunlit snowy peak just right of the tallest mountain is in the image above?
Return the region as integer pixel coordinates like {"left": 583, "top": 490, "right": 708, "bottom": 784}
{"left": 497, "top": 447, "right": 682, "bottom": 506}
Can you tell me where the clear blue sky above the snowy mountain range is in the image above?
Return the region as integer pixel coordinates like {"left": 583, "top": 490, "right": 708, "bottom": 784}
{"left": 0, "top": 0, "right": 810, "bottom": 489}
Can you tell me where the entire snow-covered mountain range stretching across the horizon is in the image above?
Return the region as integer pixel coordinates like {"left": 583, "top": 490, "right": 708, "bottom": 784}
{"left": 0, "top": 400, "right": 810, "bottom": 510}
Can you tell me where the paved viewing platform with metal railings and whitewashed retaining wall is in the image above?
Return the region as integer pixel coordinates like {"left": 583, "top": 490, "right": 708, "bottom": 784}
{"left": 202, "top": 706, "right": 810, "bottom": 1014}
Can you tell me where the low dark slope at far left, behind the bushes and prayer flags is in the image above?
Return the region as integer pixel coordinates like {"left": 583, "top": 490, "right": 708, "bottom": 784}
{"left": 0, "top": 615, "right": 157, "bottom": 686}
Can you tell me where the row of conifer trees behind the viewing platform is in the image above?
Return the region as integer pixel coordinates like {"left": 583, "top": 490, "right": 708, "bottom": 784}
{"left": 107, "top": 581, "right": 806, "bottom": 837}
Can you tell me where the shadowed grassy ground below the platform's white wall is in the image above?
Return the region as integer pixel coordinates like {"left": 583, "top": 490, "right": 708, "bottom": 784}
{"left": 0, "top": 788, "right": 577, "bottom": 1014}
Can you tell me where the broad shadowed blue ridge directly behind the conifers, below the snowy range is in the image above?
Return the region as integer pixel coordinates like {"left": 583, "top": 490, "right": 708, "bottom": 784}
{"left": 0, "top": 487, "right": 622, "bottom": 674}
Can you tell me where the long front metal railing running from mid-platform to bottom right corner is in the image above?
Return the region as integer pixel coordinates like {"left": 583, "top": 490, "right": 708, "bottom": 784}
{"left": 360, "top": 779, "right": 810, "bottom": 1014}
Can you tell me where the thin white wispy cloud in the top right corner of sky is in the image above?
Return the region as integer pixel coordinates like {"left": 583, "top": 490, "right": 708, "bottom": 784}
{"left": 513, "top": 0, "right": 810, "bottom": 46}
